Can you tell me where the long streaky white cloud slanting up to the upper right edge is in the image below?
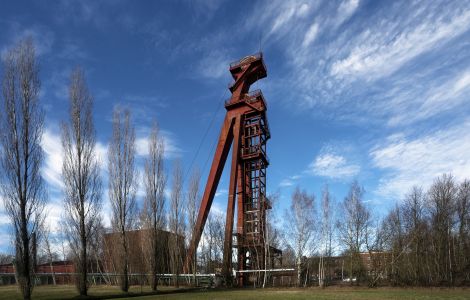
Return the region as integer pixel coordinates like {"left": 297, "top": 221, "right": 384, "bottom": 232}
{"left": 331, "top": 10, "right": 470, "bottom": 80}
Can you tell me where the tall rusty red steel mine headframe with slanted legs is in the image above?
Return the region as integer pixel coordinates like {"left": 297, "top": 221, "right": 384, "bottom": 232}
{"left": 184, "top": 53, "right": 272, "bottom": 285}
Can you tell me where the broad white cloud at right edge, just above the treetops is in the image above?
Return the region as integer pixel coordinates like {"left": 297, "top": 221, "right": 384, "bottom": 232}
{"left": 370, "top": 119, "right": 470, "bottom": 198}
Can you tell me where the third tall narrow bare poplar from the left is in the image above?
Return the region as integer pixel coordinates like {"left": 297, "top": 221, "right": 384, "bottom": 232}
{"left": 108, "top": 108, "right": 137, "bottom": 292}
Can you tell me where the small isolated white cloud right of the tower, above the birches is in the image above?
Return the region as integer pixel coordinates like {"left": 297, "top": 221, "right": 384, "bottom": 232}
{"left": 308, "top": 151, "right": 361, "bottom": 179}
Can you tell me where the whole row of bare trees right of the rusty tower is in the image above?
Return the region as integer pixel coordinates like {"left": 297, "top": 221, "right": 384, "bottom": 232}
{"left": 286, "top": 174, "right": 470, "bottom": 286}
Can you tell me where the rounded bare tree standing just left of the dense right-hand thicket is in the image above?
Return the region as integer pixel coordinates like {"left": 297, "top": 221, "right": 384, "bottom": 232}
{"left": 337, "top": 181, "right": 370, "bottom": 285}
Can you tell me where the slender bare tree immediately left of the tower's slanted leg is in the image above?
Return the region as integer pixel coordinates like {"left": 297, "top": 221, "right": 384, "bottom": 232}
{"left": 186, "top": 169, "right": 201, "bottom": 284}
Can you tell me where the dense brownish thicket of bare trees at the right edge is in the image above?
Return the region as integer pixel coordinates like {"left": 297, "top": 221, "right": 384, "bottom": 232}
{"left": 375, "top": 174, "right": 470, "bottom": 285}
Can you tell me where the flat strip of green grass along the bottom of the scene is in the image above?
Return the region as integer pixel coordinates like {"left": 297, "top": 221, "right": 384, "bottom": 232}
{"left": 0, "top": 286, "right": 470, "bottom": 300}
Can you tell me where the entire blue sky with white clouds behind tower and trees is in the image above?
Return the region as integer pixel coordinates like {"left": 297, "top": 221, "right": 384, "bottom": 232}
{"left": 0, "top": 0, "right": 470, "bottom": 251}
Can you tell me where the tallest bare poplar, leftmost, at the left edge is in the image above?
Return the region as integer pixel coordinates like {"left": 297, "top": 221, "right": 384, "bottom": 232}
{"left": 0, "top": 38, "right": 46, "bottom": 299}
